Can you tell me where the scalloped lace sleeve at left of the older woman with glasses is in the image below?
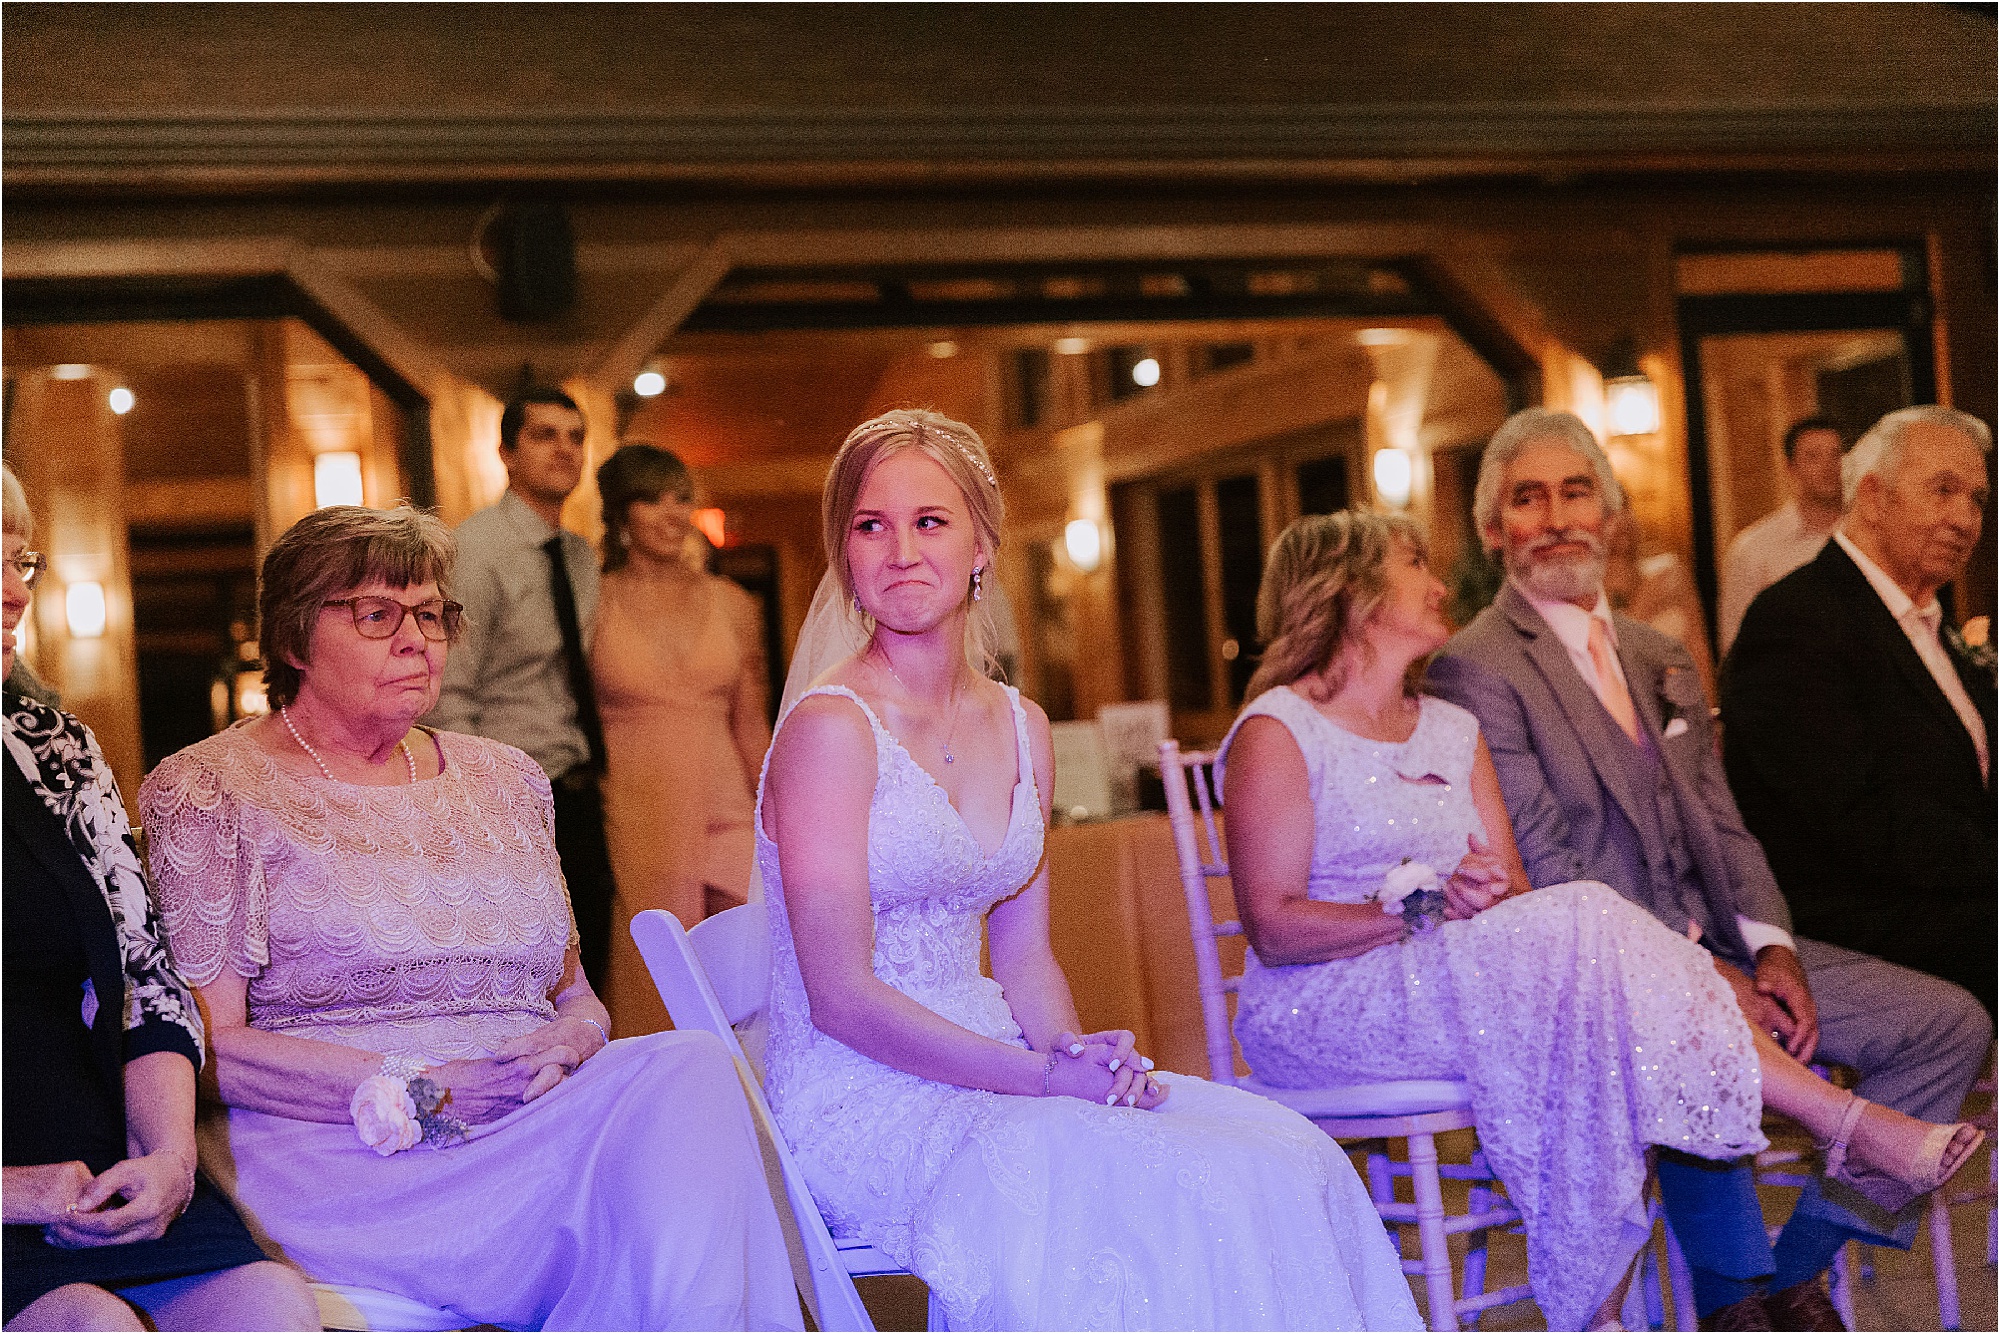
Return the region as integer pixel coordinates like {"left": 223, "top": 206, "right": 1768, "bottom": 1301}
{"left": 138, "top": 752, "right": 270, "bottom": 986}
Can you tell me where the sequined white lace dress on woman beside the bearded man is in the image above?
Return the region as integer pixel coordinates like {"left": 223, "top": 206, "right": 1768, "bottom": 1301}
{"left": 1222, "top": 686, "right": 1764, "bottom": 1330}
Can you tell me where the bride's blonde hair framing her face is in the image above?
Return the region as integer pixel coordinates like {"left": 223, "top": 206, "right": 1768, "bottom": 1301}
{"left": 820, "top": 408, "right": 1006, "bottom": 670}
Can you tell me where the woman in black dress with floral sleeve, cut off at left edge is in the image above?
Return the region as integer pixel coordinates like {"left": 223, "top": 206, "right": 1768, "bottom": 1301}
{"left": 0, "top": 472, "right": 320, "bottom": 1330}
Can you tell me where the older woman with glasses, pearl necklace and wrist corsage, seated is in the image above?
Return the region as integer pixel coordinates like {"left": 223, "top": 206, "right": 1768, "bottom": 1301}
{"left": 140, "top": 506, "right": 798, "bottom": 1330}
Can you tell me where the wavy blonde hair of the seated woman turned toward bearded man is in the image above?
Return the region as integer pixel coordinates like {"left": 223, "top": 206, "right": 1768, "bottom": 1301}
{"left": 1244, "top": 510, "right": 1428, "bottom": 700}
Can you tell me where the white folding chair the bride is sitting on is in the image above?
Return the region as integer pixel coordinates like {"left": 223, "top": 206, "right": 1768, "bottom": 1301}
{"left": 632, "top": 902, "right": 942, "bottom": 1330}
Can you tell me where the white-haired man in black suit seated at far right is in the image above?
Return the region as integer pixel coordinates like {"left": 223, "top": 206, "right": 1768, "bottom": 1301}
{"left": 1722, "top": 408, "right": 2000, "bottom": 1010}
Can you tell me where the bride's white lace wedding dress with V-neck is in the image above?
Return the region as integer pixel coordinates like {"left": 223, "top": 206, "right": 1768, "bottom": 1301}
{"left": 756, "top": 686, "right": 1420, "bottom": 1330}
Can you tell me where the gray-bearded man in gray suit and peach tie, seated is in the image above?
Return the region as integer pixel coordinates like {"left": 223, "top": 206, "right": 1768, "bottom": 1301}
{"left": 1428, "top": 408, "right": 1990, "bottom": 1330}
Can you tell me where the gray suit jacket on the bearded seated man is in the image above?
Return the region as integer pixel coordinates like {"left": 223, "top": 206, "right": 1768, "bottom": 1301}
{"left": 1426, "top": 584, "right": 1792, "bottom": 966}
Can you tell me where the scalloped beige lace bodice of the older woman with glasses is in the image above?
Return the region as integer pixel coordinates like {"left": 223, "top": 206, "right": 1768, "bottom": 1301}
{"left": 140, "top": 724, "right": 574, "bottom": 1060}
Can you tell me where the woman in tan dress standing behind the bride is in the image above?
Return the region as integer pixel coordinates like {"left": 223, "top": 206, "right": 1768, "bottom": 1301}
{"left": 590, "top": 444, "right": 770, "bottom": 1036}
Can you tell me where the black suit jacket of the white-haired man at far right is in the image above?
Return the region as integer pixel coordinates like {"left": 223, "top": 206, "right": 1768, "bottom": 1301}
{"left": 1722, "top": 542, "right": 2000, "bottom": 1008}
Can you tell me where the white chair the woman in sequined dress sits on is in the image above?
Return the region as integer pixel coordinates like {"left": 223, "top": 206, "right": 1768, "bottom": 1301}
{"left": 1160, "top": 740, "right": 1528, "bottom": 1330}
